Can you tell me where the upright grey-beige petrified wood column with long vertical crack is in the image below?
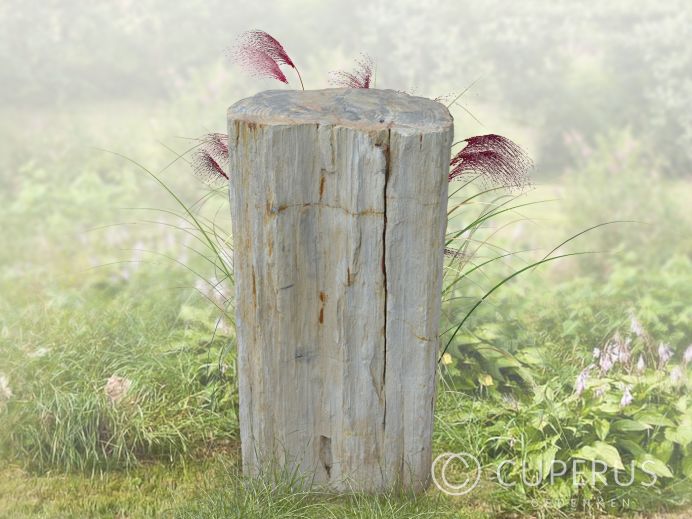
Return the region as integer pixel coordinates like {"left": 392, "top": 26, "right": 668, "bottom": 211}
{"left": 228, "top": 89, "right": 453, "bottom": 491}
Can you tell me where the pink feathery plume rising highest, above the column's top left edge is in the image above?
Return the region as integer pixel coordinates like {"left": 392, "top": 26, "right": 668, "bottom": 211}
{"left": 231, "top": 30, "right": 303, "bottom": 85}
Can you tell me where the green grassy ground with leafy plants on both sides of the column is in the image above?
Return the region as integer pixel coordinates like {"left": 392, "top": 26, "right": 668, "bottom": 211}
{"left": 0, "top": 105, "right": 692, "bottom": 518}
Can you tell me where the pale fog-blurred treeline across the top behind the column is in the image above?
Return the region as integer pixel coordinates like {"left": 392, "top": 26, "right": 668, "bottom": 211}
{"left": 0, "top": 0, "right": 692, "bottom": 178}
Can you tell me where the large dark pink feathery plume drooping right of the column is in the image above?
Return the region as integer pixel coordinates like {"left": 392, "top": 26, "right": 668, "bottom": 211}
{"left": 449, "top": 134, "right": 533, "bottom": 188}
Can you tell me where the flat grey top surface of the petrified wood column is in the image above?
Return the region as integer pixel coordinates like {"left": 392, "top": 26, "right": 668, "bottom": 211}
{"left": 228, "top": 88, "right": 452, "bottom": 132}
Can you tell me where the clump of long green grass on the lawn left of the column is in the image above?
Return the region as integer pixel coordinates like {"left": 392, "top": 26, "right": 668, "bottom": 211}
{"left": 0, "top": 268, "right": 237, "bottom": 471}
